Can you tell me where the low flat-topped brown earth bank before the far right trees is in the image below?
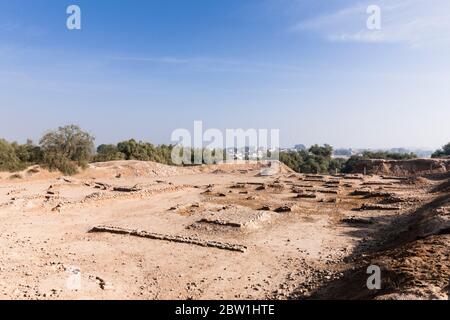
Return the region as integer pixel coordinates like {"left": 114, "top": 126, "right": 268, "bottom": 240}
{"left": 353, "top": 159, "right": 450, "bottom": 176}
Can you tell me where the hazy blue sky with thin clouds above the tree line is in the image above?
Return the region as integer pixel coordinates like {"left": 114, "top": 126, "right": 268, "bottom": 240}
{"left": 0, "top": 0, "right": 450, "bottom": 148}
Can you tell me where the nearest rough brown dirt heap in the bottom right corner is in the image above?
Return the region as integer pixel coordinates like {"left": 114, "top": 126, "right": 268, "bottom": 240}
{"left": 312, "top": 234, "right": 450, "bottom": 300}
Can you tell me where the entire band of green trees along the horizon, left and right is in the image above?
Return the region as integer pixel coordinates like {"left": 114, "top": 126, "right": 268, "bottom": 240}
{"left": 0, "top": 125, "right": 450, "bottom": 175}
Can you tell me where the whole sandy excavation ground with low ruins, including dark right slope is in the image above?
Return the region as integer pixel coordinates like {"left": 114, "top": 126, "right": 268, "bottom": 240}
{"left": 0, "top": 161, "right": 450, "bottom": 299}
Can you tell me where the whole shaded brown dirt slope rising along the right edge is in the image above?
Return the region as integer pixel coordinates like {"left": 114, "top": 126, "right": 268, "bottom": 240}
{"left": 312, "top": 193, "right": 450, "bottom": 299}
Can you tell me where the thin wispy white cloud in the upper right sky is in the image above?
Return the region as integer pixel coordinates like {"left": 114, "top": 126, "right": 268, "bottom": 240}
{"left": 294, "top": 0, "right": 450, "bottom": 47}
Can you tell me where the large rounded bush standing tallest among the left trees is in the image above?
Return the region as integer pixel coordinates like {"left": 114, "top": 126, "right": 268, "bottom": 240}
{"left": 40, "top": 125, "right": 94, "bottom": 175}
